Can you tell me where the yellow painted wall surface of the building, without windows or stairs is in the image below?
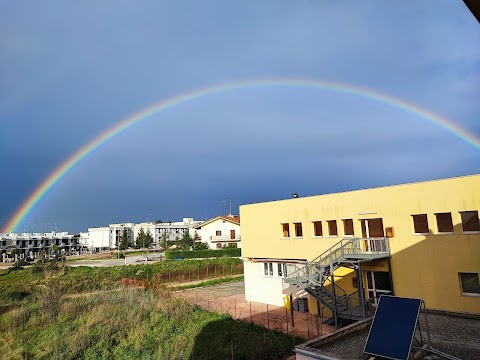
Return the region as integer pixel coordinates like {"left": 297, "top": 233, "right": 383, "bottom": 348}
{"left": 240, "top": 175, "right": 480, "bottom": 313}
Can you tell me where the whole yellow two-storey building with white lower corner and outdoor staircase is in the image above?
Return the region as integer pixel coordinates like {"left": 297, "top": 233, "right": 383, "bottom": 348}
{"left": 240, "top": 175, "right": 480, "bottom": 320}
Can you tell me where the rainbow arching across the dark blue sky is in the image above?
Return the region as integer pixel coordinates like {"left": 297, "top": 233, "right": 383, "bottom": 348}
{"left": 2, "top": 78, "right": 480, "bottom": 233}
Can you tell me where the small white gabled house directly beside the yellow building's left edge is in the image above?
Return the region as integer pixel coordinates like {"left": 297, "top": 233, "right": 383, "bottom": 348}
{"left": 194, "top": 215, "right": 242, "bottom": 249}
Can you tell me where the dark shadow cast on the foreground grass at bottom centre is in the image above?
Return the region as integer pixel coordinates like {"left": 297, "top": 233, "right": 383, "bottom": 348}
{"left": 189, "top": 316, "right": 304, "bottom": 360}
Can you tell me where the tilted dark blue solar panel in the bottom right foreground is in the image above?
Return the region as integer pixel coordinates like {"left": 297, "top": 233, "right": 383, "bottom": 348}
{"left": 363, "top": 295, "right": 422, "bottom": 360}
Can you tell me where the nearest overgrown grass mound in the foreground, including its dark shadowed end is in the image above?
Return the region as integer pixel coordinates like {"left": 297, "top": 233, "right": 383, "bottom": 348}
{"left": 0, "top": 286, "right": 302, "bottom": 360}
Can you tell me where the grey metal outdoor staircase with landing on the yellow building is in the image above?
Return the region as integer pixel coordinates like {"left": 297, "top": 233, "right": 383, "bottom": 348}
{"left": 284, "top": 238, "right": 390, "bottom": 327}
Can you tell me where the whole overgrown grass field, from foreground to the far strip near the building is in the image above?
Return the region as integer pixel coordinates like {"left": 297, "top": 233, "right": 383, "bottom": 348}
{"left": 0, "top": 259, "right": 301, "bottom": 360}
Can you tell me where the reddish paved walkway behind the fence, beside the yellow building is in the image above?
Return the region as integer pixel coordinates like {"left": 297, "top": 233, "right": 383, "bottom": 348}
{"left": 174, "top": 281, "right": 335, "bottom": 339}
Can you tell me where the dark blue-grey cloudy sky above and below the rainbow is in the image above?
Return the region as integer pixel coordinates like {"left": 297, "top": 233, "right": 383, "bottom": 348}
{"left": 0, "top": 0, "right": 480, "bottom": 232}
